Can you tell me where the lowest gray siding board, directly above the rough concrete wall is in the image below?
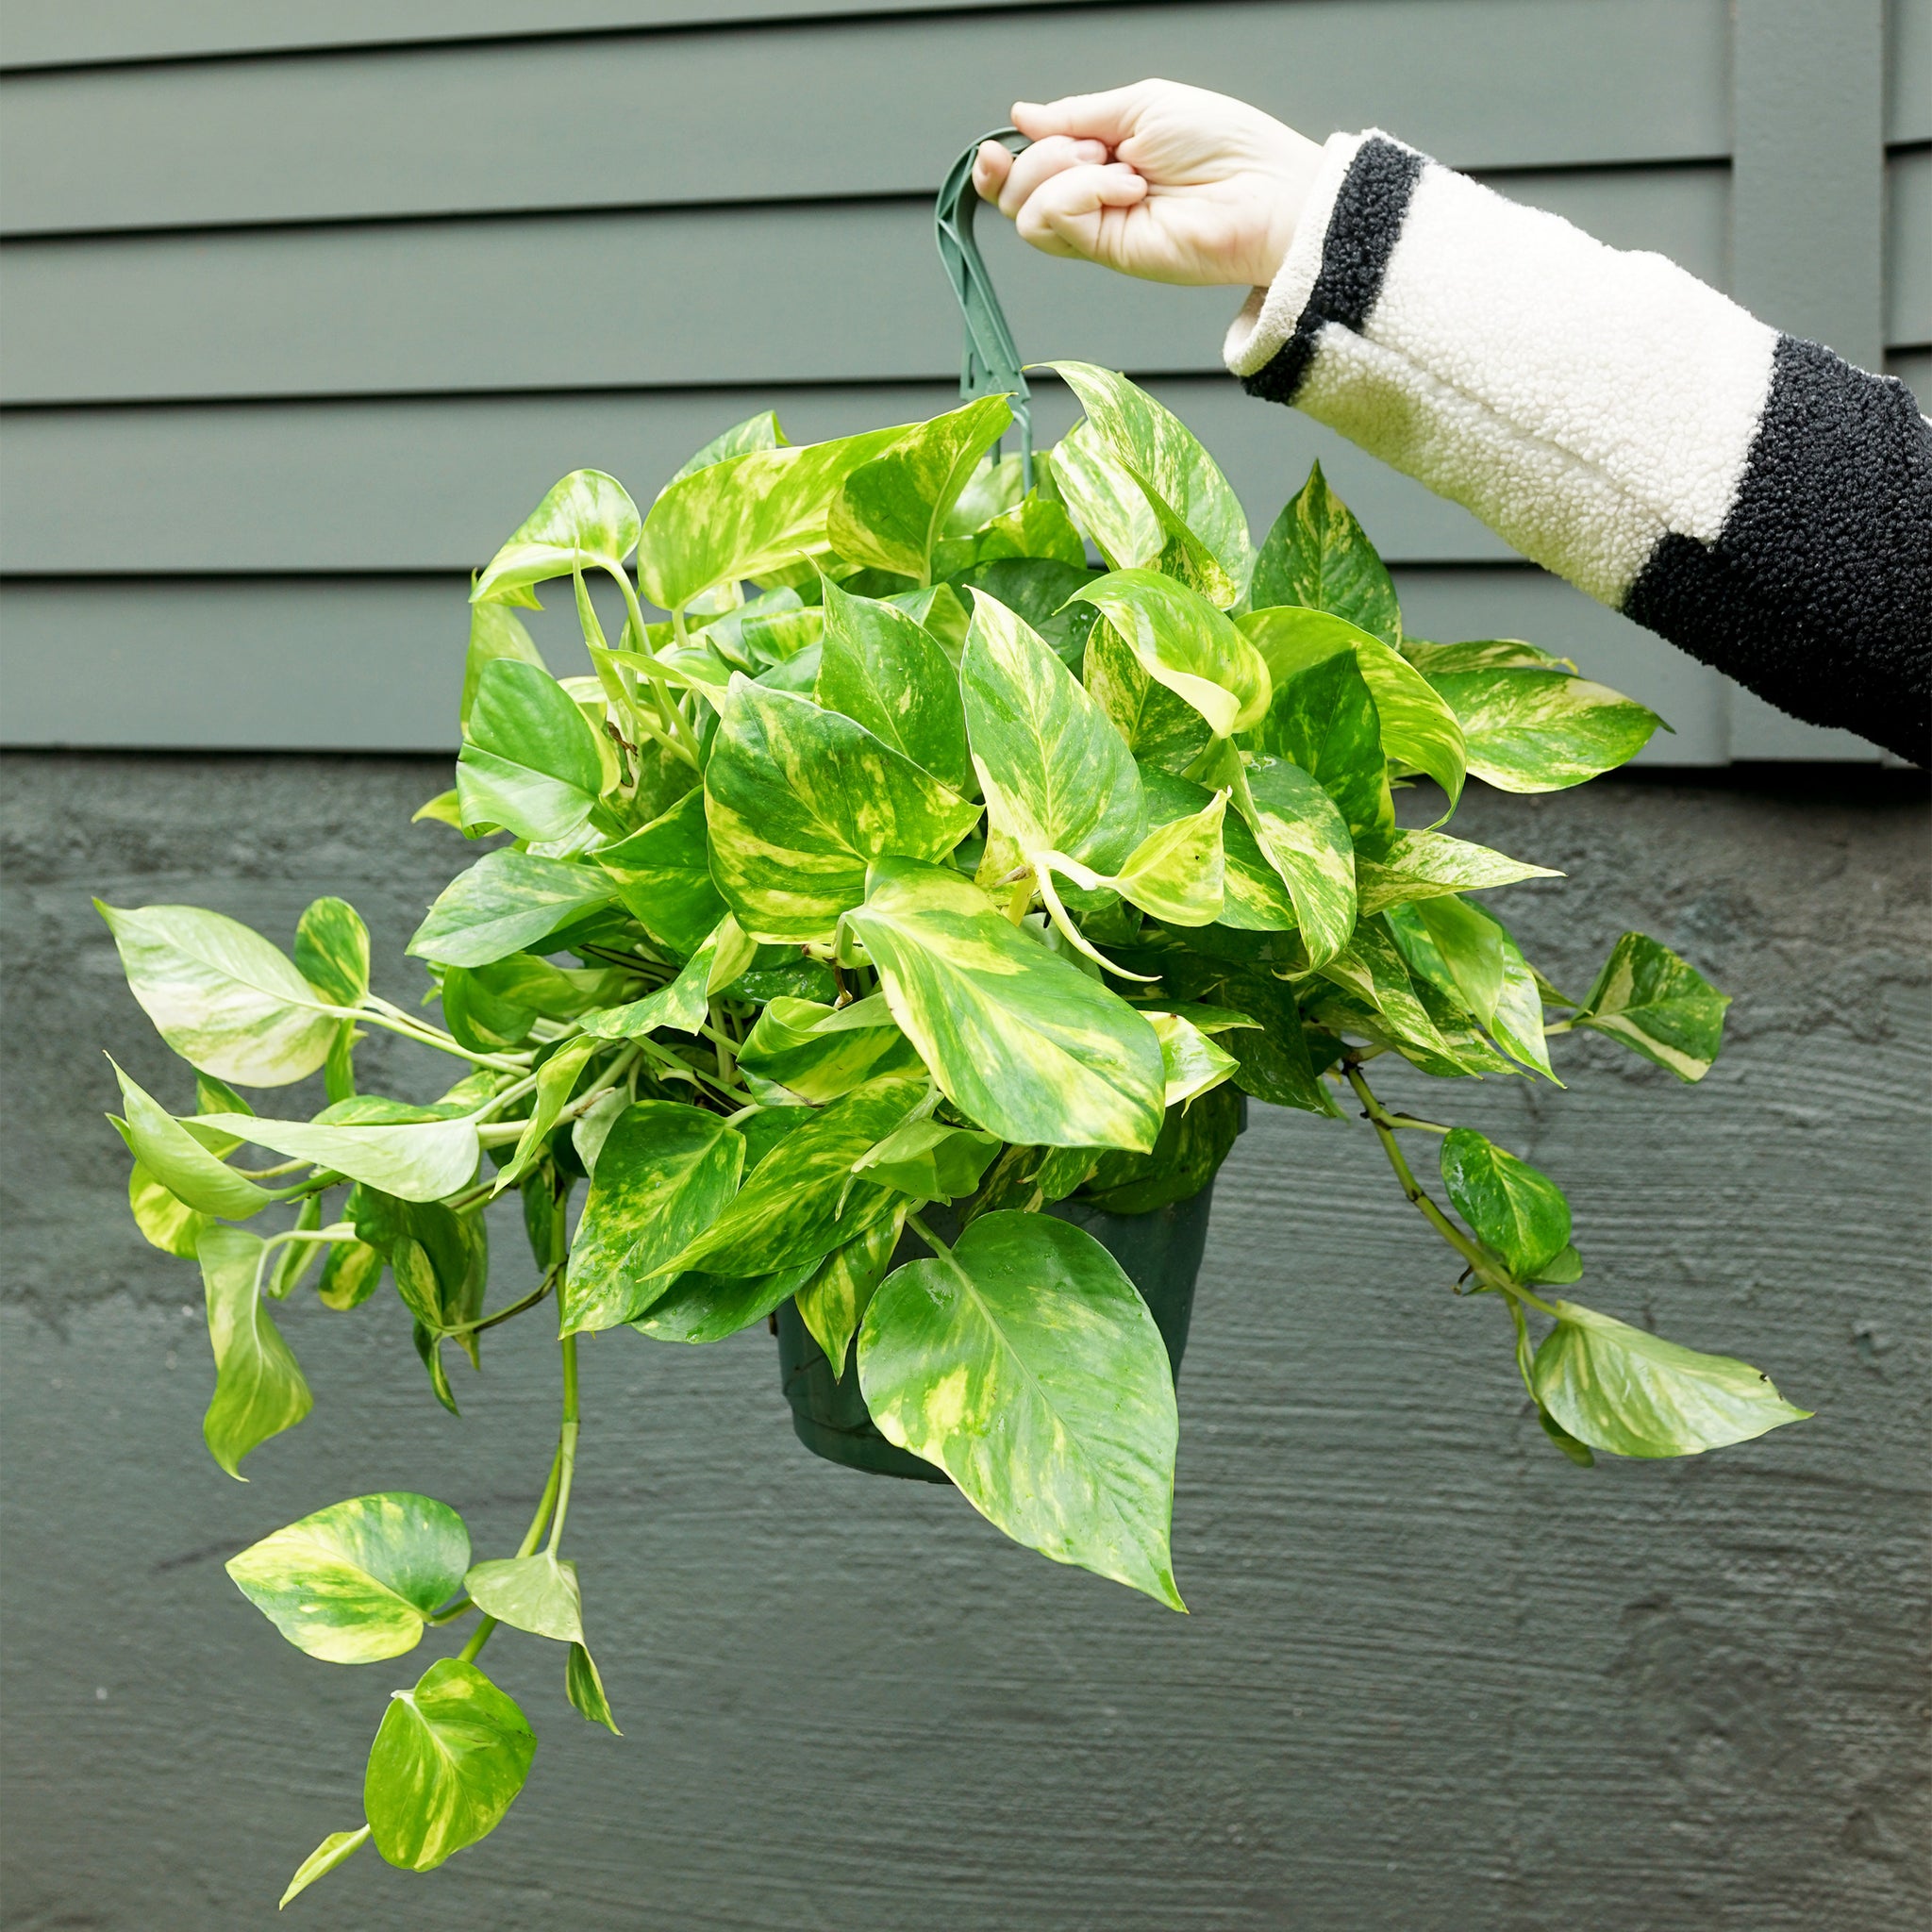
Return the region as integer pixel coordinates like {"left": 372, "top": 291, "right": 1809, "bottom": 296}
{"left": 0, "top": 564, "right": 1739, "bottom": 765}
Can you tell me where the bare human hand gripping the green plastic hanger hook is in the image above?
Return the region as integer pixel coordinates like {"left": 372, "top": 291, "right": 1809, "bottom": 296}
{"left": 974, "top": 81, "right": 1322, "bottom": 288}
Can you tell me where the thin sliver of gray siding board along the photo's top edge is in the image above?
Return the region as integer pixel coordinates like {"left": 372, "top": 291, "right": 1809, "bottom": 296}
{"left": 0, "top": 0, "right": 1097, "bottom": 72}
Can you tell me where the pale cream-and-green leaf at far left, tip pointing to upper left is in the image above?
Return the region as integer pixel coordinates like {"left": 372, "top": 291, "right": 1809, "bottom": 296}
{"left": 94, "top": 898, "right": 338, "bottom": 1086}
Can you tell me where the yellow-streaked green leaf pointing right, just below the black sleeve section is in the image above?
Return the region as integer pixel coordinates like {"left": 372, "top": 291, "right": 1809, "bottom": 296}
{"left": 1427, "top": 671, "right": 1663, "bottom": 792}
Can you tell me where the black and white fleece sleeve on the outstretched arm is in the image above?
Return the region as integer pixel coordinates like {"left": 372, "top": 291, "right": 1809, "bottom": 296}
{"left": 1226, "top": 131, "right": 1932, "bottom": 763}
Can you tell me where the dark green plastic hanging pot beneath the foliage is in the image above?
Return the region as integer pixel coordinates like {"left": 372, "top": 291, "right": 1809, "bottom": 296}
{"left": 778, "top": 1180, "right": 1213, "bottom": 1482}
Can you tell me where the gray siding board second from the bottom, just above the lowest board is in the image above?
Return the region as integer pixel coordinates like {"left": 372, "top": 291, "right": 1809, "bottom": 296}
{"left": 0, "top": 375, "right": 1538, "bottom": 575}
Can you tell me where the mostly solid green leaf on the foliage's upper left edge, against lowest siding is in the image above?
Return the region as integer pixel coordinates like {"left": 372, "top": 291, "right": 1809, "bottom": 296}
{"left": 456, "top": 657, "right": 603, "bottom": 841}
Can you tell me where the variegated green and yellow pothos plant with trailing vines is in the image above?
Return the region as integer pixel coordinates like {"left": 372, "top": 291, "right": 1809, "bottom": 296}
{"left": 103, "top": 363, "right": 1805, "bottom": 1903}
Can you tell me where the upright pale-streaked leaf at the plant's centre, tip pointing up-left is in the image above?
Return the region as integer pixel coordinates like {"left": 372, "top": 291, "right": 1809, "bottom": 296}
{"left": 958, "top": 579, "right": 1141, "bottom": 872}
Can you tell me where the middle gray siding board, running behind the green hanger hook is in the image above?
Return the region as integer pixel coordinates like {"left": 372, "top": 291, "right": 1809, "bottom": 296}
{"left": 0, "top": 166, "right": 1727, "bottom": 404}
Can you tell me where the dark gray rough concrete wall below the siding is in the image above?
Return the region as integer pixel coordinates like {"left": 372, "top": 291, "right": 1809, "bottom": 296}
{"left": 0, "top": 754, "right": 1932, "bottom": 1932}
